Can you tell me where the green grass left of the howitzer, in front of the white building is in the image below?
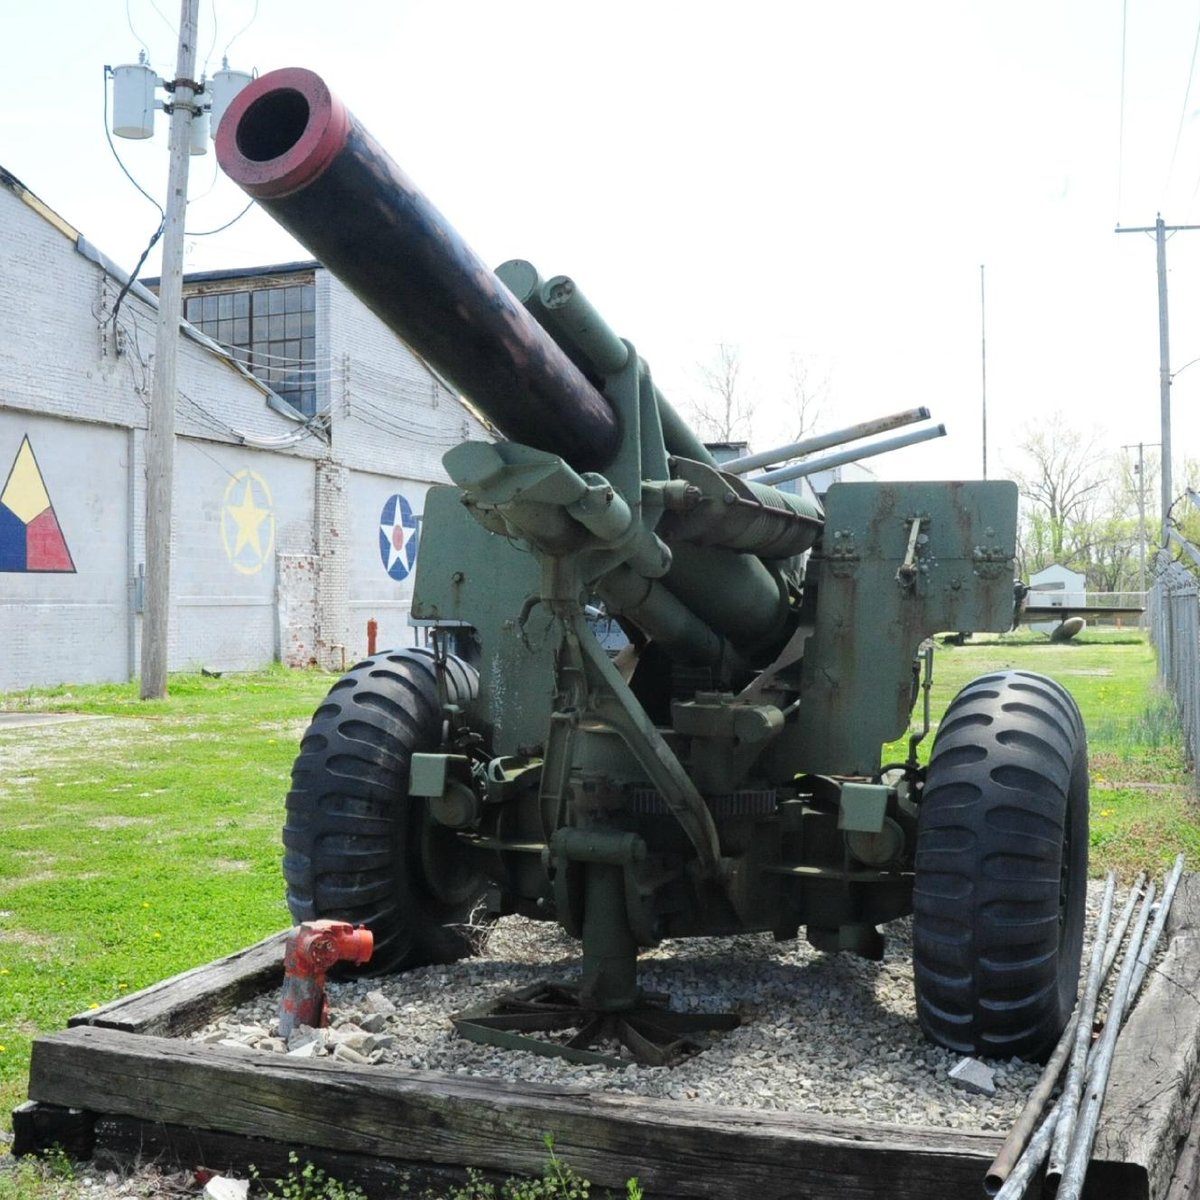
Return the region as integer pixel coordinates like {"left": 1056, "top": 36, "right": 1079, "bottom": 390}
{"left": 0, "top": 670, "right": 331, "bottom": 1126}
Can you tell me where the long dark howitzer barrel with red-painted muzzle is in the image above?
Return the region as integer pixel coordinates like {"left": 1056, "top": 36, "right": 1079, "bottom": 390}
{"left": 216, "top": 67, "right": 620, "bottom": 470}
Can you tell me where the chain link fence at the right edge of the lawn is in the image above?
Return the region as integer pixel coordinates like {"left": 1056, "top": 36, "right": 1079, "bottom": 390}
{"left": 1150, "top": 544, "right": 1200, "bottom": 774}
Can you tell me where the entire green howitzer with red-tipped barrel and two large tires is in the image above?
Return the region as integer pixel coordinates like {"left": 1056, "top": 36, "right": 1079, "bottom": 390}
{"left": 217, "top": 68, "right": 1087, "bottom": 1061}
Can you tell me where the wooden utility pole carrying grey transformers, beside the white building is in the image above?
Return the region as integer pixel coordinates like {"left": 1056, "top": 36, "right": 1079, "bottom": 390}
{"left": 142, "top": 0, "right": 200, "bottom": 700}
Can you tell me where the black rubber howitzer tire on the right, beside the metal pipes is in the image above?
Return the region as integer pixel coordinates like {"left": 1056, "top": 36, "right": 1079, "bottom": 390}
{"left": 913, "top": 671, "right": 1087, "bottom": 1061}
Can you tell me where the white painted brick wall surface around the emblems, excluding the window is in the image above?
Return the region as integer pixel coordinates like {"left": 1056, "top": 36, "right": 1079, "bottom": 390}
{"left": 0, "top": 186, "right": 486, "bottom": 690}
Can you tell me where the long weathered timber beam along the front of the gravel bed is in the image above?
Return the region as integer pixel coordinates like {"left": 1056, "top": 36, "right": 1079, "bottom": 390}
{"left": 30, "top": 1026, "right": 1041, "bottom": 1200}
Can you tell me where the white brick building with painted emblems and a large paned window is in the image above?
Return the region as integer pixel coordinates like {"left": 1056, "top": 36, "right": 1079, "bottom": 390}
{"left": 0, "top": 169, "right": 486, "bottom": 690}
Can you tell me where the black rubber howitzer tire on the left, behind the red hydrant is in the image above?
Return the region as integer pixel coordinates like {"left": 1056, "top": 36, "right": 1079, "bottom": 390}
{"left": 283, "top": 648, "right": 485, "bottom": 974}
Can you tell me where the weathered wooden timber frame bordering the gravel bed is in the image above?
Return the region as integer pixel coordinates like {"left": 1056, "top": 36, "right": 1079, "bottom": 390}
{"left": 14, "top": 875, "right": 1200, "bottom": 1200}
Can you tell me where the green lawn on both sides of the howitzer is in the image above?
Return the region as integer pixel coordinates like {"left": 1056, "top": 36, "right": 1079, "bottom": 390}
{"left": 0, "top": 635, "right": 1200, "bottom": 1152}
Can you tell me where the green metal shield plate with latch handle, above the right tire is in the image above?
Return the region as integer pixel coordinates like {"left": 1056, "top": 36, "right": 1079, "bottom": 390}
{"left": 775, "top": 480, "right": 1016, "bottom": 776}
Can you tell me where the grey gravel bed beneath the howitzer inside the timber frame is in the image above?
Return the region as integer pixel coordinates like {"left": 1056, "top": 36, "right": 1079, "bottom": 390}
{"left": 192, "top": 882, "right": 1123, "bottom": 1132}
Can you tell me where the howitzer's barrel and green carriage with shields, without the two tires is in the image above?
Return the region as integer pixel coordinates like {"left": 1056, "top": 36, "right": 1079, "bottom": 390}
{"left": 222, "top": 72, "right": 1041, "bottom": 1062}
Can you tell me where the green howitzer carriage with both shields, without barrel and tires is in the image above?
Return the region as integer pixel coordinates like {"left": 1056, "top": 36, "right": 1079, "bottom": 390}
{"left": 414, "top": 314, "right": 1016, "bottom": 1036}
